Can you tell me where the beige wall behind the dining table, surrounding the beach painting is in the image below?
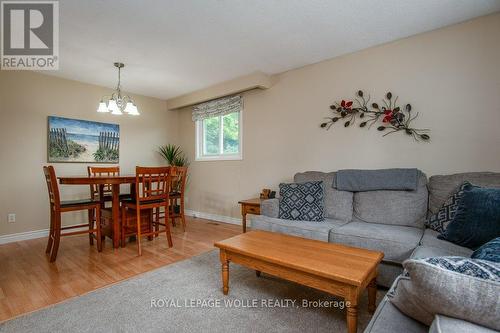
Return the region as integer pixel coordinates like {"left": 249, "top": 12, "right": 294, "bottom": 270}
{"left": 0, "top": 71, "right": 177, "bottom": 235}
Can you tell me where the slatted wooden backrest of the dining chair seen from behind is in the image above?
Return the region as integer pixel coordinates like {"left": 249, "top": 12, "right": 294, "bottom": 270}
{"left": 135, "top": 166, "right": 172, "bottom": 205}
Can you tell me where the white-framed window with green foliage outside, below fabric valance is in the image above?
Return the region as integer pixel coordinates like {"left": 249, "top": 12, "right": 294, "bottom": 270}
{"left": 196, "top": 111, "right": 243, "bottom": 161}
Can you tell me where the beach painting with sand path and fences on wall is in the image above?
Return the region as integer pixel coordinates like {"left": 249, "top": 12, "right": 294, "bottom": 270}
{"left": 47, "top": 116, "right": 120, "bottom": 163}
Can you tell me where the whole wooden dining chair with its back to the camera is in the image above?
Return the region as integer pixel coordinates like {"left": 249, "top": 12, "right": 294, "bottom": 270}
{"left": 121, "top": 166, "right": 173, "bottom": 255}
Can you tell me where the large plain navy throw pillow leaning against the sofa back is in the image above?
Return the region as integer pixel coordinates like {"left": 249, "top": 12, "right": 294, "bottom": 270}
{"left": 438, "top": 185, "right": 500, "bottom": 250}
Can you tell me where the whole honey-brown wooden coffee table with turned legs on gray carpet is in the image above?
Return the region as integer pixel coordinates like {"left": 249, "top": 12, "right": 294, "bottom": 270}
{"left": 215, "top": 231, "right": 384, "bottom": 333}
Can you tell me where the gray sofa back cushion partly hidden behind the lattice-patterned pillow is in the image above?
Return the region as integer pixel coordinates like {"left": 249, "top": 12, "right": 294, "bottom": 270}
{"left": 293, "top": 171, "right": 353, "bottom": 221}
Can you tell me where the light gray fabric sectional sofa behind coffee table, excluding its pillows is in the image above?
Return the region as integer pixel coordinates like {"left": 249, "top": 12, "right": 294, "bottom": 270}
{"left": 248, "top": 171, "right": 500, "bottom": 333}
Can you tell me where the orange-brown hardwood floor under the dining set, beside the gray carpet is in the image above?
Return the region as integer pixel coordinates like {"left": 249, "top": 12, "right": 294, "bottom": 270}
{"left": 0, "top": 218, "right": 241, "bottom": 321}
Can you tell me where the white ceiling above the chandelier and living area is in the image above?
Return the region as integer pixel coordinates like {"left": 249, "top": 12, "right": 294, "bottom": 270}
{"left": 46, "top": 0, "right": 500, "bottom": 99}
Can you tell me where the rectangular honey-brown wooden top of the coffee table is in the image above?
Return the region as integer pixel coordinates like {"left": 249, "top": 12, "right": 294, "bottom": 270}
{"left": 215, "top": 230, "right": 384, "bottom": 286}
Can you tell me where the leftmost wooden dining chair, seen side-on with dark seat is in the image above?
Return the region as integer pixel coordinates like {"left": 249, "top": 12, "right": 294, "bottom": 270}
{"left": 43, "top": 165, "right": 102, "bottom": 262}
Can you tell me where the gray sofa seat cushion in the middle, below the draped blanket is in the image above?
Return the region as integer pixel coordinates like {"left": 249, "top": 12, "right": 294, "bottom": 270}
{"left": 329, "top": 221, "right": 423, "bottom": 264}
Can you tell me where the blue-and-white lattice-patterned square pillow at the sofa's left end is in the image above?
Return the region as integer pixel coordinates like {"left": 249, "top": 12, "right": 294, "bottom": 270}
{"left": 279, "top": 181, "right": 324, "bottom": 221}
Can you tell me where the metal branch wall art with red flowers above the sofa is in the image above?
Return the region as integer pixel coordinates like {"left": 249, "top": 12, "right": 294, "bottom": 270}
{"left": 321, "top": 90, "right": 430, "bottom": 141}
